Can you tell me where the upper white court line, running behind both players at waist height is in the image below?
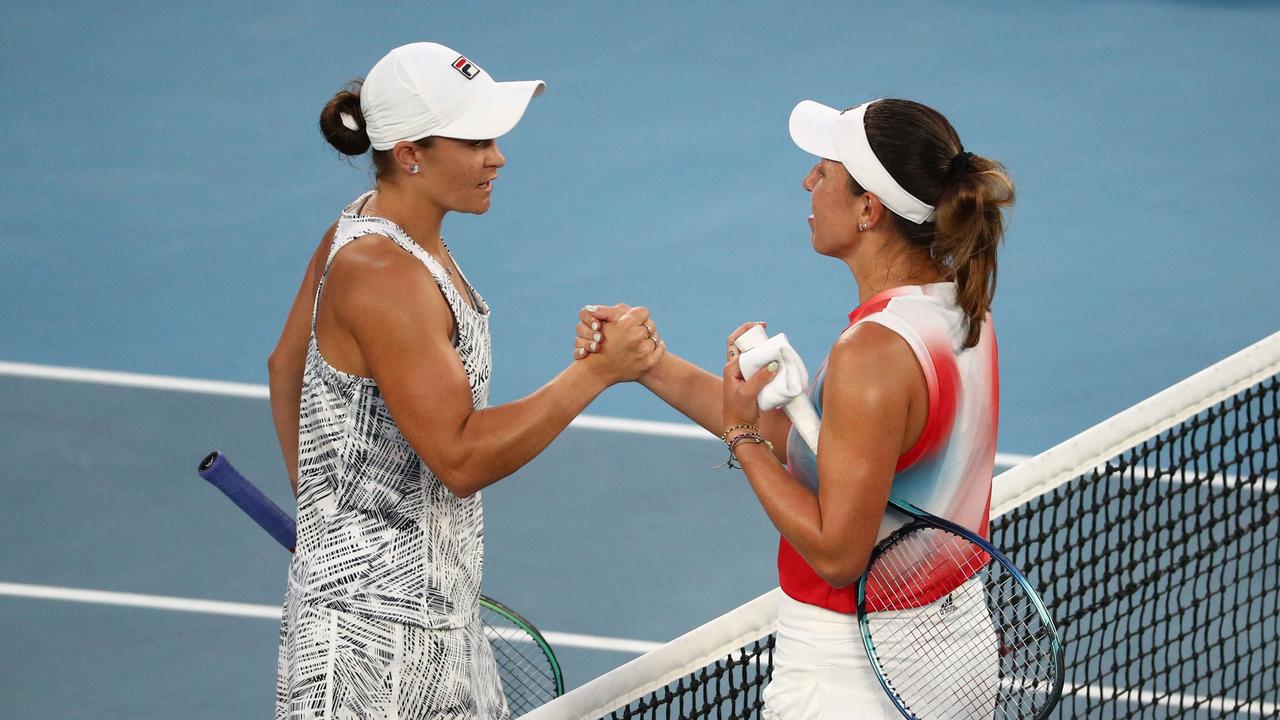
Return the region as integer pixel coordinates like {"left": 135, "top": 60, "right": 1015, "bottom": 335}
{"left": 0, "top": 361, "right": 1030, "bottom": 458}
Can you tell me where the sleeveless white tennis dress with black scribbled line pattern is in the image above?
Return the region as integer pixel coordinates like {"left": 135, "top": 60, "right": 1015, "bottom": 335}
{"left": 275, "top": 193, "right": 508, "bottom": 720}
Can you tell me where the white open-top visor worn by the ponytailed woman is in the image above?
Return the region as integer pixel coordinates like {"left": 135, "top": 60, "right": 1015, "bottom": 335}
{"left": 790, "top": 100, "right": 934, "bottom": 225}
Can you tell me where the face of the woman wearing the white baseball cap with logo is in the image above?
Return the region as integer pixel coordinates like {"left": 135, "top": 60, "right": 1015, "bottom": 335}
{"left": 407, "top": 137, "right": 507, "bottom": 215}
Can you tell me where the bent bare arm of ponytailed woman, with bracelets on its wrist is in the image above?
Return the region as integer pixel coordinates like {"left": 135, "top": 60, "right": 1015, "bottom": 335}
{"left": 724, "top": 324, "right": 927, "bottom": 587}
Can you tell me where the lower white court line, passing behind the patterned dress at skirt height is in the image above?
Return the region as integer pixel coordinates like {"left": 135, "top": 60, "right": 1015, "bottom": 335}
{"left": 0, "top": 583, "right": 662, "bottom": 655}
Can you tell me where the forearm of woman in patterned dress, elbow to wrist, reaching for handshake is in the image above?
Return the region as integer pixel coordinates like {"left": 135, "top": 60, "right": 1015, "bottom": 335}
{"left": 442, "top": 361, "right": 609, "bottom": 497}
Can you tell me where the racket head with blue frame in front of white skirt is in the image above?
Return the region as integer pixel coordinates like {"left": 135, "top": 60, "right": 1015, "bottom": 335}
{"left": 858, "top": 518, "right": 1064, "bottom": 720}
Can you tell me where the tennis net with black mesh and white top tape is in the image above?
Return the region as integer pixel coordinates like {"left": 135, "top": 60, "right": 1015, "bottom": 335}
{"left": 526, "top": 333, "right": 1280, "bottom": 720}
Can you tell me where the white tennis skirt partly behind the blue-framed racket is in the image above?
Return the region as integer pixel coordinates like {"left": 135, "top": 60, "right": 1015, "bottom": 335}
{"left": 763, "top": 580, "right": 998, "bottom": 720}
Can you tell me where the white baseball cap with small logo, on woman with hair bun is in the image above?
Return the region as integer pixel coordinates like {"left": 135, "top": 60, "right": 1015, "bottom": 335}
{"left": 360, "top": 42, "right": 547, "bottom": 150}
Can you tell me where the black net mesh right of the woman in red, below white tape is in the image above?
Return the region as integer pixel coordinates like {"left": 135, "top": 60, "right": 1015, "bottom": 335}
{"left": 992, "top": 375, "right": 1280, "bottom": 717}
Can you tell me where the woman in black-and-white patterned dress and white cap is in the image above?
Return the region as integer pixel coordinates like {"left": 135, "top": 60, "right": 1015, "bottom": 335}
{"left": 269, "top": 42, "right": 663, "bottom": 720}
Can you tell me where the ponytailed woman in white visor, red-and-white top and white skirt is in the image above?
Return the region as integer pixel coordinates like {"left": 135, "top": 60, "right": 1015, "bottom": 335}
{"left": 575, "top": 100, "right": 1014, "bottom": 720}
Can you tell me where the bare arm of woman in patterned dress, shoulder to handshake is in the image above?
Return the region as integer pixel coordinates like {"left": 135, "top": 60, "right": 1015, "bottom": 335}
{"left": 321, "top": 241, "right": 662, "bottom": 497}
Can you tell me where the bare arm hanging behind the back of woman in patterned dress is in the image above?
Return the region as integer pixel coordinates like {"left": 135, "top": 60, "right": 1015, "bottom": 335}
{"left": 266, "top": 225, "right": 337, "bottom": 496}
